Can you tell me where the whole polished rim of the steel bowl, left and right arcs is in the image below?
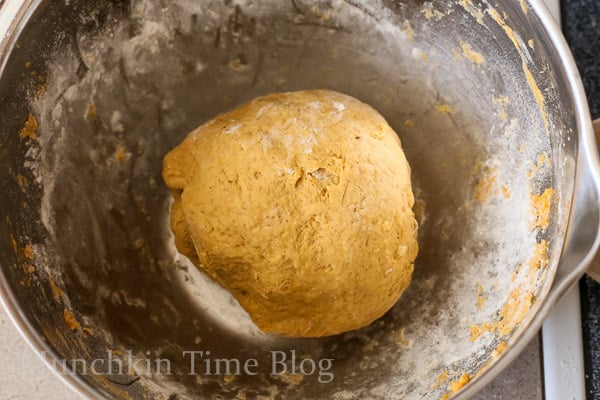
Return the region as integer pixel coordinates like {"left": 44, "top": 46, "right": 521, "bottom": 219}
{"left": 0, "top": 0, "right": 600, "bottom": 400}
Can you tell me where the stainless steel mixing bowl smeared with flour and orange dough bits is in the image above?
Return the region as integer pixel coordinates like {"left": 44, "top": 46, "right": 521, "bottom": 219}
{"left": 0, "top": 0, "right": 599, "bottom": 400}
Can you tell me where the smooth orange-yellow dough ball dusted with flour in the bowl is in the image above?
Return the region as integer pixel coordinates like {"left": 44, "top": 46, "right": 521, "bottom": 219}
{"left": 163, "top": 90, "right": 418, "bottom": 337}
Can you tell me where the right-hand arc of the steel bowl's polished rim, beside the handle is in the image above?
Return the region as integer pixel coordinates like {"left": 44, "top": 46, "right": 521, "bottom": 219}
{"left": 451, "top": 0, "right": 600, "bottom": 400}
